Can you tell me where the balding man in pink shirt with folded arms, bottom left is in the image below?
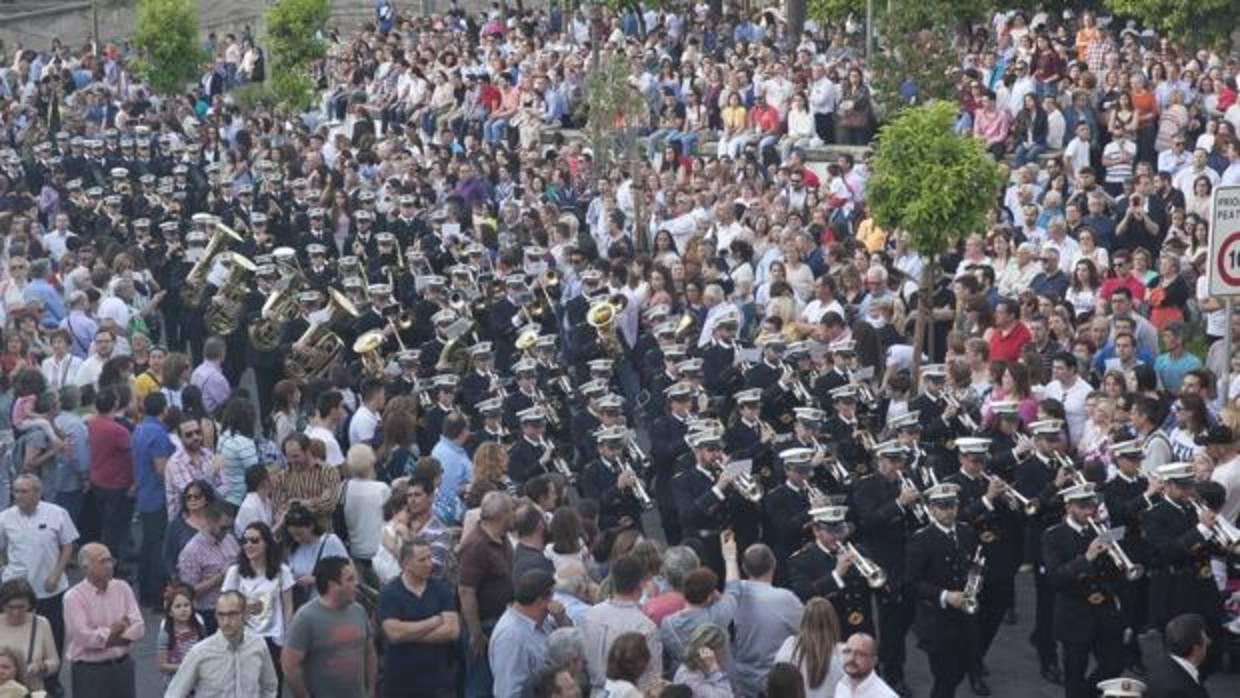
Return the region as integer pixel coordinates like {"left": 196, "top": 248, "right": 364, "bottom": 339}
{"left": 64, "top": 543, "right": 146, "bottom": 698}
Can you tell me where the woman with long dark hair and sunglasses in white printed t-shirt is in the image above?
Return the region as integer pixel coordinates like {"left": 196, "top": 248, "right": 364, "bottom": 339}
{"left": 219, "top": 521, "right": 296, "bottom": 693}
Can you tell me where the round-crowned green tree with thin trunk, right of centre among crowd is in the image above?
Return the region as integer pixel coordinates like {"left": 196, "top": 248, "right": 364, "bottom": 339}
{"left": 866, "top": 100, "right": 999, "bottom": 381}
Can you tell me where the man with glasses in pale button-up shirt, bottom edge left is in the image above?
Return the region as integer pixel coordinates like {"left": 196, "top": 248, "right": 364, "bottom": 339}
{"left": 164, "top": 591, "right": 280, "bottom": 698}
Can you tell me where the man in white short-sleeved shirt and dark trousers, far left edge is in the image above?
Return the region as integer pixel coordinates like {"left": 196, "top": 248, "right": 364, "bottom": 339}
{"left": 0, "top": 474, "right": 78, "bottom": 669}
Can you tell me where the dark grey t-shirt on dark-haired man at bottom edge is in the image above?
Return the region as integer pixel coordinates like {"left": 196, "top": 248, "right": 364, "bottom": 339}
{"left": 288, "top": 600, "right": 371, "bottom": 698}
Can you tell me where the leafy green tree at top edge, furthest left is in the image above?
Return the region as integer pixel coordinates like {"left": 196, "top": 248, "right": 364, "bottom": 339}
{"left": 133, "top": 0, "right": 207, "bottom": 93}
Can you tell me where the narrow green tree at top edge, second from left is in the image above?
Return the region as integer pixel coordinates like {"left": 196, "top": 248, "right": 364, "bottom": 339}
{"left": 264, "top": 0, "right": 331, "bottom": 112}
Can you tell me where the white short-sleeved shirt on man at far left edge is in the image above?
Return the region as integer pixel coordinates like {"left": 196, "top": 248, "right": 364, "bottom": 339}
{"left": 0, "top": 502, "right": 78, "bottom": 599}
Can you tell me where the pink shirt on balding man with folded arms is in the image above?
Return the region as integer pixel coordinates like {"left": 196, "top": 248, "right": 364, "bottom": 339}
{"left": 64, "top": 579, "right": 146, "bottom": 662}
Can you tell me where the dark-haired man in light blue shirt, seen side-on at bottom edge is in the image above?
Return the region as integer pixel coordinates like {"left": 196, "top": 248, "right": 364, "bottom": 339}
{"left": 487, "top": 569, "right": 573, "bottom": 698}
